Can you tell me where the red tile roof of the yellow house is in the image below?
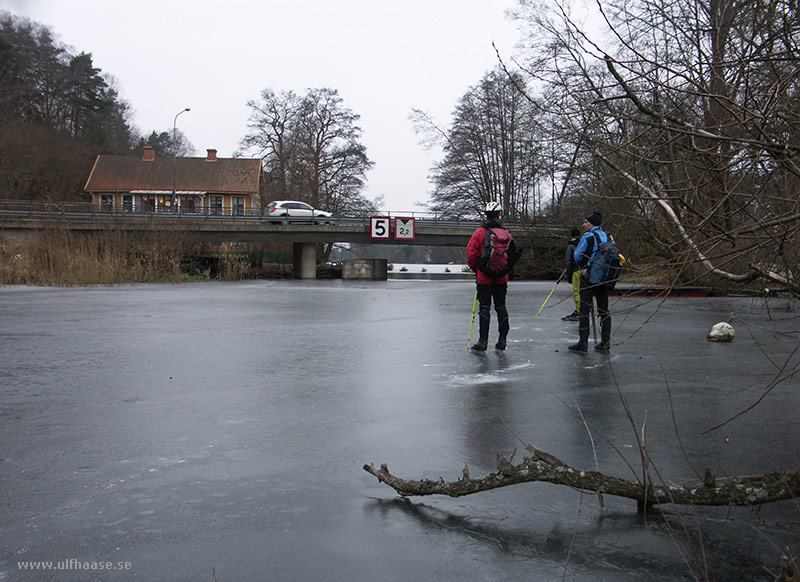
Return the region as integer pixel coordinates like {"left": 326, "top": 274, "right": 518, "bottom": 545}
{"left": 84, "top": 155, "right": 263, "bottom": 194}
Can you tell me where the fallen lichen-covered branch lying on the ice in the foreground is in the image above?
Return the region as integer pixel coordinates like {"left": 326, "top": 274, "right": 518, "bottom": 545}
{"left": 364, "top": 444, "right": 800, "bottom": 510}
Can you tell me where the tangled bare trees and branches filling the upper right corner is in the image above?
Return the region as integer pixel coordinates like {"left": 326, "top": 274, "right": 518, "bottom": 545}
{"left": 510, "top": 0, "right": 800, "bottom": 292}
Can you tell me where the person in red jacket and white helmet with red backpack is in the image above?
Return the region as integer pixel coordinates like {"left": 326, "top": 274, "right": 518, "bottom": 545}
{"left": 467, "top": 202, "right": 521, "bottom": 351}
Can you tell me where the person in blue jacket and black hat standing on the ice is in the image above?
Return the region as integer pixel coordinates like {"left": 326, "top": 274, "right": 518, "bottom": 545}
{"left": 569, "top": 212, "right": 611, "bottom": 352}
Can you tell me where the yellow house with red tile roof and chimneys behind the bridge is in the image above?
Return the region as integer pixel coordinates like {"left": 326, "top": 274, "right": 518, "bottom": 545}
{"left": 84, "top": 146, "right": 264, "bottom": 215}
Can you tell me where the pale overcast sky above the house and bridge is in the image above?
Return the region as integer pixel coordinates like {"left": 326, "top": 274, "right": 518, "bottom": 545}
{"left": 0, "top": 0, "right": 517, "bottom": 211}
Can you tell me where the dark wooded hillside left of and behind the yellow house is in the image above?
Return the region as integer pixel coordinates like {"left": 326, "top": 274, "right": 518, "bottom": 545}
{"left": 0, "top": 12, "right": 191, "bottom": 200}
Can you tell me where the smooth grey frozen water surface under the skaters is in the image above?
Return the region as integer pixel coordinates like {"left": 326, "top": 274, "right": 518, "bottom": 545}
{"left": 0, "top": 281, "right": 800, "bottom": 582}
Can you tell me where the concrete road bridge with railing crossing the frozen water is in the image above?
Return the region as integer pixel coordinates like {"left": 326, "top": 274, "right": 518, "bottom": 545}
{"left": 0, "top": 200, "right": 568, "bottom": 279}
